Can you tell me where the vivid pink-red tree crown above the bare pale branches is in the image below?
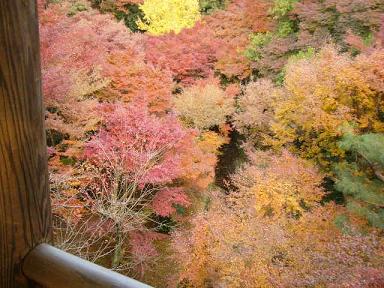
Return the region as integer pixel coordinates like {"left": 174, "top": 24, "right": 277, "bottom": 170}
{"left": 85, "top": 105, "right": 186, "bottom": 184}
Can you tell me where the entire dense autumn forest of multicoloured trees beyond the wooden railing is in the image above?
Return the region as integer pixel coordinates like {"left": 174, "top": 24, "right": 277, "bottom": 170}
{"left": 38, "top": 0, "right": 384, "bottom": 288}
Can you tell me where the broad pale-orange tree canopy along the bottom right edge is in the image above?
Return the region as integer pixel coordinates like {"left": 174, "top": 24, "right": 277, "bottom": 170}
{"left": 172, "top": 192, "right": 384, "bottom": 288}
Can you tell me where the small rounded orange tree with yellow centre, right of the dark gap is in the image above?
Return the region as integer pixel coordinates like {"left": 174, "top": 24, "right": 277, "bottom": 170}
{"left": 231, "top": 151, "right": 323, "bottom": 217}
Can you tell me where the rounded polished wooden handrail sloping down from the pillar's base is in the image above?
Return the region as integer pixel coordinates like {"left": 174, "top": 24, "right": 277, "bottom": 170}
{"left": 23, "top": 244, "right": 151, "bottom": 288}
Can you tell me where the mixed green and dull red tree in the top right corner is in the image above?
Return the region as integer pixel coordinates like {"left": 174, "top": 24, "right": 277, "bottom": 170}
{"left": 246, "top": 0, "right": 384, "bottom": 82}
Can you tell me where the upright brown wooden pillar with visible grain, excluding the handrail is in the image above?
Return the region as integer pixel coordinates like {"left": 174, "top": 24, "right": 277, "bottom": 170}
{"left": 0, "top": 0, "right": 51, "bottom": 288}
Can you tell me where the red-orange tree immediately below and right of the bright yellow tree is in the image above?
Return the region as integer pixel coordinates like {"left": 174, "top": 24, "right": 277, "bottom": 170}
{"left": 146, "top": 0, "right": 269, "bottom": 85}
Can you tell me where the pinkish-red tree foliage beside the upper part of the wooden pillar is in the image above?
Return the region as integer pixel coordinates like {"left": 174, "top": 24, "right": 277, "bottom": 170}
{"left": 40, "top": 4, "right": 143, "bottom": 100}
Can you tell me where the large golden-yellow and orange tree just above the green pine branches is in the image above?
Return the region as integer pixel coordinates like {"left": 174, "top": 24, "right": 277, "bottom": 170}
{"left": 267, "top": 45, "right": 384, "bottom": 167}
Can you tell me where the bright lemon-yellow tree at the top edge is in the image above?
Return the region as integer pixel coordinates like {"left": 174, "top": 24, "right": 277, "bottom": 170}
{"left": 137, "top": 0, "right": 200, "bottom": 35}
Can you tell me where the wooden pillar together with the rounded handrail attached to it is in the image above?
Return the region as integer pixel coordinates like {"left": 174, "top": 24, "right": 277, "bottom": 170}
{"left": 0, "top": 0, "right": 150, "bottom": 288}
